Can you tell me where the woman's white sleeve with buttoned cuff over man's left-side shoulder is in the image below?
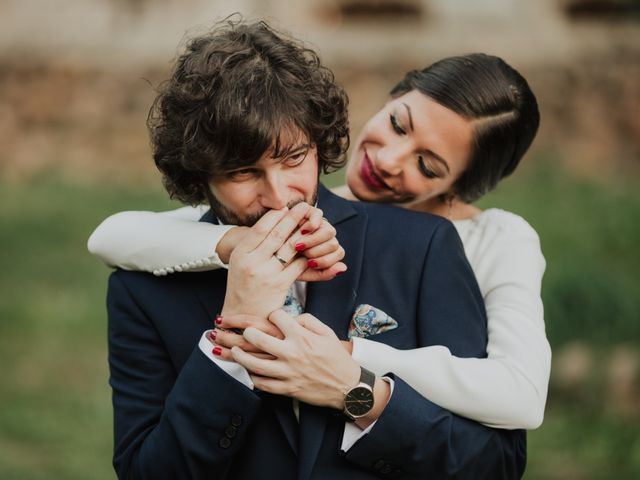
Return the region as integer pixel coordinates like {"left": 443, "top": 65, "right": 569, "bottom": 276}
{"left": 87, "top": 207, "right": 233, "bottom": 275}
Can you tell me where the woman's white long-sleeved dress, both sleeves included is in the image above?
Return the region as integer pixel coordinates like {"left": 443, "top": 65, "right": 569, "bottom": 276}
{"left": 88, "top": 207, "right": 551, "bottom": 429}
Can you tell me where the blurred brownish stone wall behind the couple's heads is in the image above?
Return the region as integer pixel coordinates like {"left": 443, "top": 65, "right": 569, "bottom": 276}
{"left": 0, "top": 0, "right": 640, "bottom": 177}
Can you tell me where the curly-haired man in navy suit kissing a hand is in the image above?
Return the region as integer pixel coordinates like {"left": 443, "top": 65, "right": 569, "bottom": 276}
{"left": 108, "top": 16, "right": 518, "bottom": 479}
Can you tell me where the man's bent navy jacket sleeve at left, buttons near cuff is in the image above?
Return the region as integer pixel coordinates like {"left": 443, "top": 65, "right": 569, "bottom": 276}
{"left": 107, "top": 272, "right": 261, "bottom": 479}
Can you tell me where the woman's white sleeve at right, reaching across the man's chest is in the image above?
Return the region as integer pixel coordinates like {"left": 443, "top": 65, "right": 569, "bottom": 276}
{"left": 353, "top": 225, "right": 551, "bottom": 429}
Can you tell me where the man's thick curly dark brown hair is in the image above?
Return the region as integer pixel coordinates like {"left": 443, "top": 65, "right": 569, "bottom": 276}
{"left": 147, "top": 19, "right": 349, "bottom": 205}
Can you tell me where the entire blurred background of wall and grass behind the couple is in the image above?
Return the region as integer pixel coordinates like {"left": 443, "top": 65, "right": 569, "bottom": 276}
{"left": 0, "top": 0, "right": 640, "bottom": 479}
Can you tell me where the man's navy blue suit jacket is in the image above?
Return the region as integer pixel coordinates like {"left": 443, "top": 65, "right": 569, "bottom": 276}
{"left": 108, "top": 187, "right": 525, "bottom": 480}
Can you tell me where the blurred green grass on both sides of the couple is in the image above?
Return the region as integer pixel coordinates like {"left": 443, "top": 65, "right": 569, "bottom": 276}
{"left": 0, "top": 166, "right": 640, "bottom": 480}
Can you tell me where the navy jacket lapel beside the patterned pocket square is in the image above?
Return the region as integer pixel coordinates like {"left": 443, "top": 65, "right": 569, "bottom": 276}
{"left": 299, "top": 186, "right": 367, "bottom": 480}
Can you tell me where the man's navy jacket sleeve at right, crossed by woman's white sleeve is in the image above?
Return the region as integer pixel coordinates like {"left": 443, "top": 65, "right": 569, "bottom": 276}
{"left": 346, "top": 222, "right": 526, "bottom": 480}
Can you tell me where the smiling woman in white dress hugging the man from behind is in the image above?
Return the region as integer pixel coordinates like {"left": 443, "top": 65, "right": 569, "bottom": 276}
{"left": 89, "top": 54, "right": 551, "bottom": 429}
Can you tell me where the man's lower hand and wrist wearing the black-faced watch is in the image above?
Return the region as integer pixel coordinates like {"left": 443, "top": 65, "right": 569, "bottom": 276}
{"left": 209, "top": 310, "right": 391, "bottom": 429}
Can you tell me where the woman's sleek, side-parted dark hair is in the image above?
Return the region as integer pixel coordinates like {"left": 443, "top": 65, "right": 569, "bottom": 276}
{"left": 391, "top": 53, "right": 540, "bottom": 203}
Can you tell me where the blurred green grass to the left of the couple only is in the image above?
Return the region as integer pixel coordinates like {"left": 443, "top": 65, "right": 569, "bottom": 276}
{"left": 0, "top": 175, "right": 178, "bottom": 480}
